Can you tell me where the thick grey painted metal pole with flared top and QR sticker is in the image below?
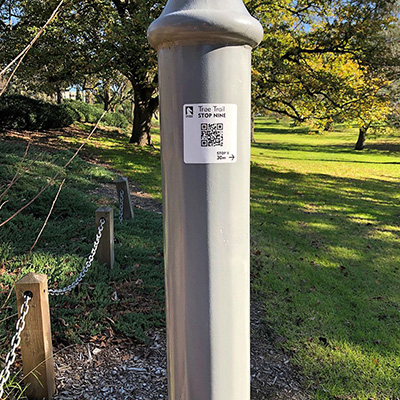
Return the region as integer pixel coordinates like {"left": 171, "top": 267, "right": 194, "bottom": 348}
{"left": 148, "top": 0, "right": 262, "bottom": 400}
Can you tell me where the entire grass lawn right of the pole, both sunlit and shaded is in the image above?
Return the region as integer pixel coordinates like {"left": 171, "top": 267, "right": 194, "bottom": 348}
{"left": 251, "top": 120, "right": 400, "bottom": 399}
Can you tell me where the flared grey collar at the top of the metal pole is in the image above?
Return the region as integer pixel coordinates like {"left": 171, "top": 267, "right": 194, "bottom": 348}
{"left": 147, "top": 0, "right": 263, "bottom": 50}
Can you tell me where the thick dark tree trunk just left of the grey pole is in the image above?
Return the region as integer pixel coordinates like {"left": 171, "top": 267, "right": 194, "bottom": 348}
{"left": 129, "top": 87, "right": 158, "bottom": 146}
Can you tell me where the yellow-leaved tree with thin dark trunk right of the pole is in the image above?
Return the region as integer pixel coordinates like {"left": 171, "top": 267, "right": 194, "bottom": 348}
{"left": 248, "top": 0, "right": 398, "bottom": 149}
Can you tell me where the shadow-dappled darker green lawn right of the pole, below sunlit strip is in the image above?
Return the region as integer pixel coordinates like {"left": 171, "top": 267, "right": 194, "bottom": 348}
{"left": 251, "top": 165, "right": 400, "bottom": 398}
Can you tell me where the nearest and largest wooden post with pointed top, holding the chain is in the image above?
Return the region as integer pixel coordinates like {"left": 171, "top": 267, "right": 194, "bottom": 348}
{"left": 15, "top": 273, "right": 55, "bottom": 400}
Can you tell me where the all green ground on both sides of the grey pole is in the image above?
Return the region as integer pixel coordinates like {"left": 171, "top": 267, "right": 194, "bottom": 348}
{"left": 0, "top": 119, "right": 400, "bottom": 400}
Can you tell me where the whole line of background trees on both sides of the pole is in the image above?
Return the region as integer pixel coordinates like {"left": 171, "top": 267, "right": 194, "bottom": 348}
{"left": 0, "top": 0, "right": 399, "bottom": 149}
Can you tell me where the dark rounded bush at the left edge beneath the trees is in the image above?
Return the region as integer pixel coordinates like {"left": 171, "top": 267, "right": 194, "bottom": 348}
{"left": 0, "top": 95, "right": 76, "bottom": 130}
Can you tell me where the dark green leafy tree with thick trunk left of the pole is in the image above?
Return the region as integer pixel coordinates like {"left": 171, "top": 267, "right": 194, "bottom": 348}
{"left": 1, "top": 0, "right": 165, "bottom": 145}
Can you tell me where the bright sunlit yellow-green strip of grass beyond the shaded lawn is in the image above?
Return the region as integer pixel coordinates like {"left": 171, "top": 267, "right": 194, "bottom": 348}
{"left": 252, "top": 120, "right": 400, "bottom": 180}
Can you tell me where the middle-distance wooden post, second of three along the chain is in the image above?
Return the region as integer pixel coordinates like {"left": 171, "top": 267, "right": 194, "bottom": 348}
{"left": 96, "top": 207, "right": 114, "bottom": 268}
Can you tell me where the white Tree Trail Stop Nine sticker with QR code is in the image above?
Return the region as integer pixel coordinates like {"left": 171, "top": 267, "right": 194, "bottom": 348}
{"left": 183, "top": 104, "right": 237, "bottom": 164}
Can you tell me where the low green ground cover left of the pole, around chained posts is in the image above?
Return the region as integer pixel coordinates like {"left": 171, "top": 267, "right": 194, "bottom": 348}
{"left": 0, "top": 141, "right": 164, "bottom": 347}
